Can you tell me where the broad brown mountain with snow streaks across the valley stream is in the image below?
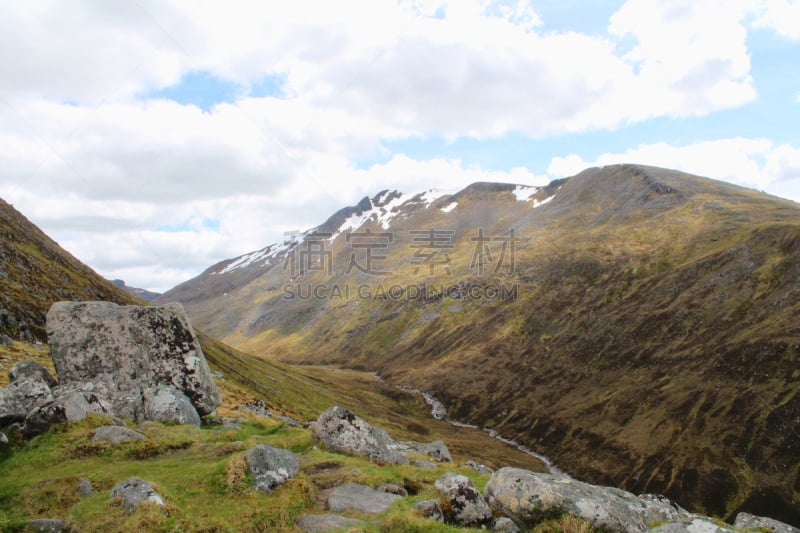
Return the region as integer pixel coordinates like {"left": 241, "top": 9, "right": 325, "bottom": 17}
{"left": 157, "top": 165, "right": 800, "bottom": 523}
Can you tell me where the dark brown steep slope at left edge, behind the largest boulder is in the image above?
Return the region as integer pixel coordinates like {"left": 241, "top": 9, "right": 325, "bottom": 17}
{"left": 0, "top": 200, "right": 140, "bottom": 341}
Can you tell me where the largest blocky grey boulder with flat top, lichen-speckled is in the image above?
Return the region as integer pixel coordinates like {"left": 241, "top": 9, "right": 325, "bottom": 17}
{"left": 47, "top": 302, "right": 221, "bottom": 420}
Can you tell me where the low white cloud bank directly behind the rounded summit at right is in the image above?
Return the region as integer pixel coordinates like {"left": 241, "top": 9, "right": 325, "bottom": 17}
{"left": 548, "top": 137, "right": 800, "bottom": 201}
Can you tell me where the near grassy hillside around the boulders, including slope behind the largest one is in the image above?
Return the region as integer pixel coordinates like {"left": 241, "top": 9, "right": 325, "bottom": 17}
{"left": 0, "top": 335, "right": 564, "bottom": 532}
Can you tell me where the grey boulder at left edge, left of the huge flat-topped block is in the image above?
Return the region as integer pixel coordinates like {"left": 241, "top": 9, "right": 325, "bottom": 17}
{"left": 0, "top": 361, "right": 56, "bottom": 427}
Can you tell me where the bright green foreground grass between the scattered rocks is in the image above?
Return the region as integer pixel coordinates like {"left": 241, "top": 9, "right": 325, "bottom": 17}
{"left": 0, "top": 415, "right": 564, "bottom": 532}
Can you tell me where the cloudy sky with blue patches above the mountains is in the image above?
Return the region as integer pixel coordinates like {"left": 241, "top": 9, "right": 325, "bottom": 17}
{"left": 0, "top": 0, "right": 800, "bottom": 291}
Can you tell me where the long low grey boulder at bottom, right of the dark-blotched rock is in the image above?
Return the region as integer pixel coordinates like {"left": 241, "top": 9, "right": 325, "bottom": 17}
{"left": 484, "top": 467, "right": 682, "bottom": 532}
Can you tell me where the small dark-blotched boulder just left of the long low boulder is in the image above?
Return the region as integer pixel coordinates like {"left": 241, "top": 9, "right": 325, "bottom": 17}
{"left": 434, "top": 472, "right": 492, "bottom": 527}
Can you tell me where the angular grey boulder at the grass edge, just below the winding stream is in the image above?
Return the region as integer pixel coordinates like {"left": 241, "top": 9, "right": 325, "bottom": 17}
{"left": 312, "top": 407, "right": 408, "bottom": 464}
